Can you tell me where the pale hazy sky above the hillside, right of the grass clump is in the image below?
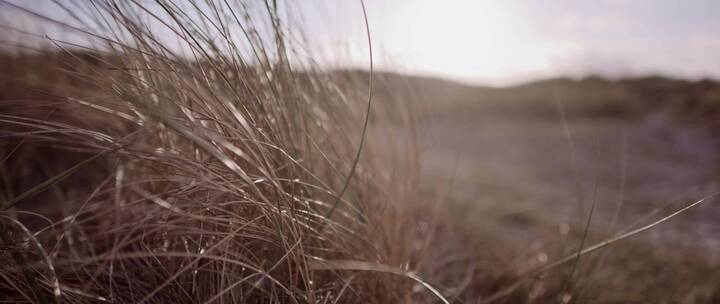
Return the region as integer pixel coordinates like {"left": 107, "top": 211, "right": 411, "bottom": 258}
{"left": 0, "top": 0, "right": 720, "bottom": 85}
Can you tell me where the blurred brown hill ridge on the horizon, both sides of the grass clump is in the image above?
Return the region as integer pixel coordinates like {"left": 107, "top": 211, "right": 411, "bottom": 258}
{"left": 0, "top": 52, "right": 720, "bottom": 128}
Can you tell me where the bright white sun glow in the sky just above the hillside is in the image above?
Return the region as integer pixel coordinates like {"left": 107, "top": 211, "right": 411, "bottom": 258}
{"left": 379, "top": 0, "right": 562, "bottom": 83}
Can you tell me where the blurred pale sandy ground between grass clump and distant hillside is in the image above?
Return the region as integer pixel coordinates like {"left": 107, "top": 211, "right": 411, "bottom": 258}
{"left": 419, "top": 86, "right": 720, "bottom": 263}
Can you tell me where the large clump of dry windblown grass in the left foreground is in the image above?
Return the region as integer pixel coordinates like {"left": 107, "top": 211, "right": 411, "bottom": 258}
{"left": 0, "top": 0, "right": 450, "bottom": 303}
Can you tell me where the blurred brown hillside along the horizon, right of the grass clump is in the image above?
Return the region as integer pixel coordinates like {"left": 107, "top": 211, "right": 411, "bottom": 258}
{"left": 341, "top": 71, "right": 720, "bottom": 128}
